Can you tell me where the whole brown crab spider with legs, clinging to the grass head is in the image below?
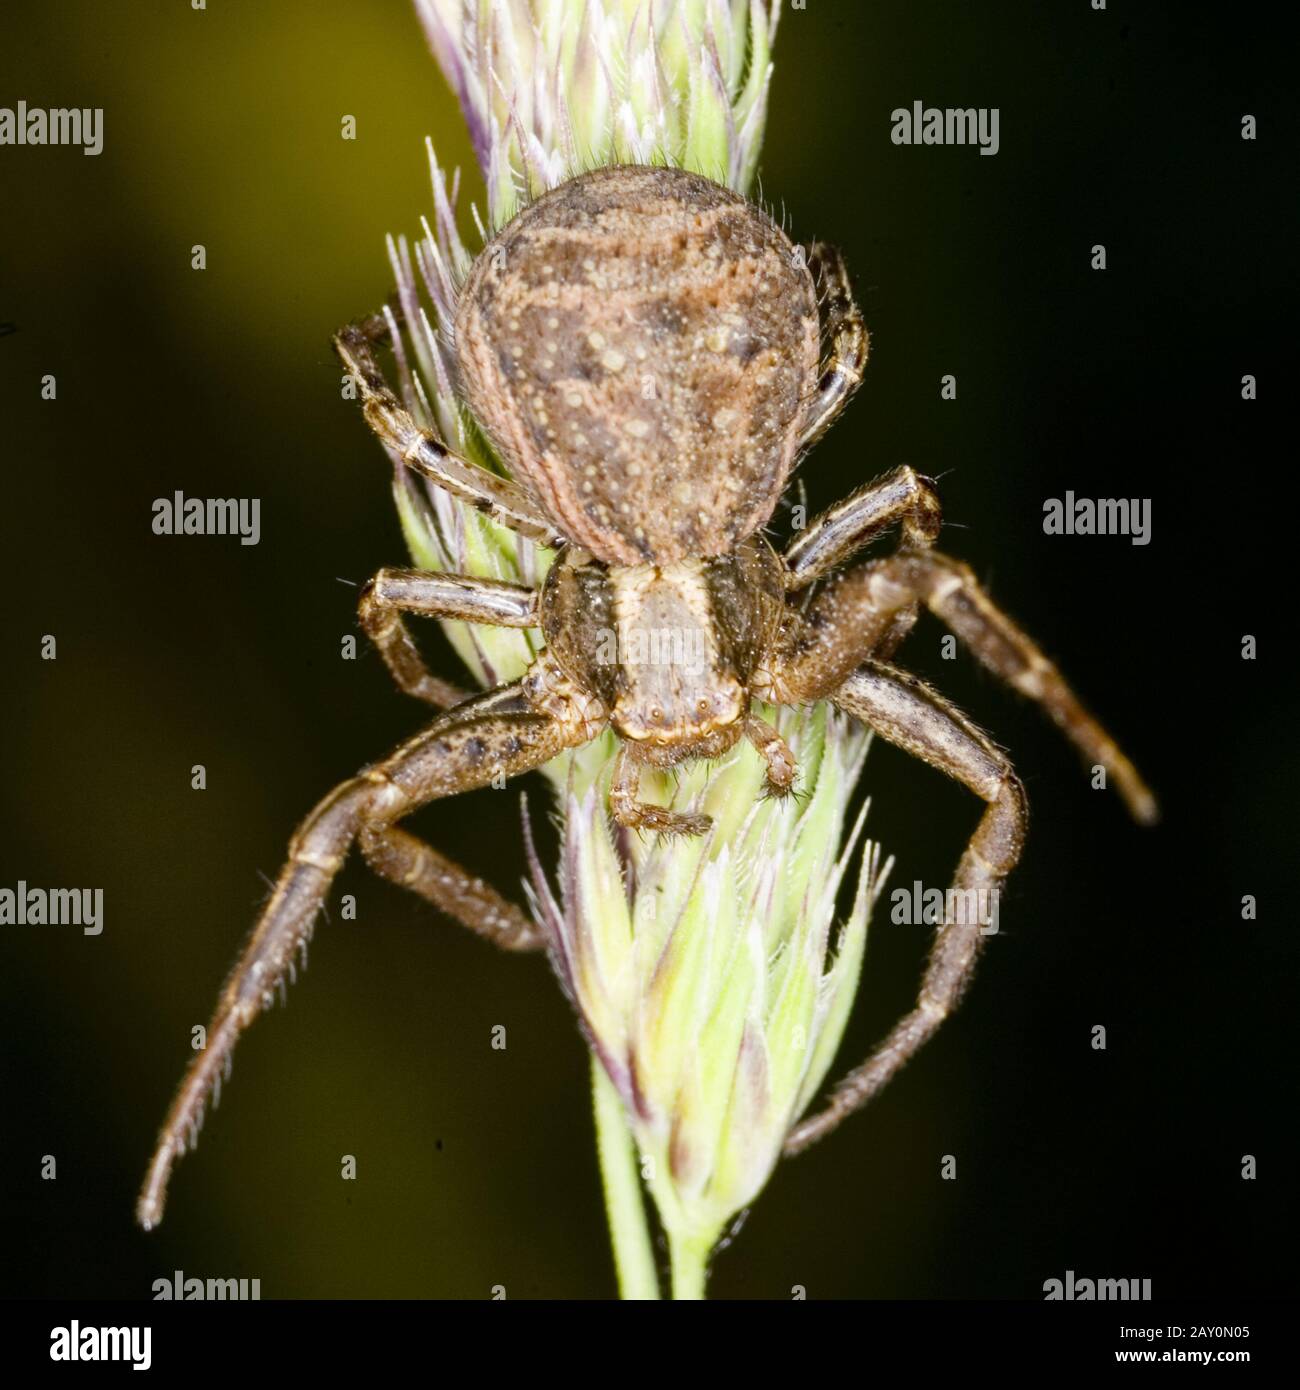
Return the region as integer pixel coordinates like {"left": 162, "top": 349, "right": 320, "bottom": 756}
{"left": 139, "top": 159, "right": 1155, "bottom": 1226}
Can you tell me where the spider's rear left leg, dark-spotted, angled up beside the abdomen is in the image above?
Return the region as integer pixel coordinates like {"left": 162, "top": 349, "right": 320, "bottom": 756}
{"left": 334, "top": 314, "right": 564, "bottom": 549}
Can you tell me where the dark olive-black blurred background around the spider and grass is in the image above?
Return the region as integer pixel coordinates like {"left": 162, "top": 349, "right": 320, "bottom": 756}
{"left": 0, "top": 0, "right": 1296, "bottom": 1298}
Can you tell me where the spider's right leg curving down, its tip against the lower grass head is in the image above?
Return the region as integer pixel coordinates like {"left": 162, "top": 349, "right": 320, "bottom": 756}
{"left": 786, "top": 662, "right": 1027, "bottom": 1154}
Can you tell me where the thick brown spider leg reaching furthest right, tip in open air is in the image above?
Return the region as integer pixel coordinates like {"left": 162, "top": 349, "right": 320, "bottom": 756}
{"left": 756, "top": 549, "right": 1158, "bottom": 824}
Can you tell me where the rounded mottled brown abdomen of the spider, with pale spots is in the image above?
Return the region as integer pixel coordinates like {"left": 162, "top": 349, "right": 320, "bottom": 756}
{"left": 456, "top": 167, "right": 819, "bottom": 564}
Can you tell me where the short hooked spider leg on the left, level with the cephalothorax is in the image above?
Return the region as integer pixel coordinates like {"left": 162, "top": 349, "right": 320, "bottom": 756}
{"left": 357, "top": 569, "right": 538, "bottom": 709}
